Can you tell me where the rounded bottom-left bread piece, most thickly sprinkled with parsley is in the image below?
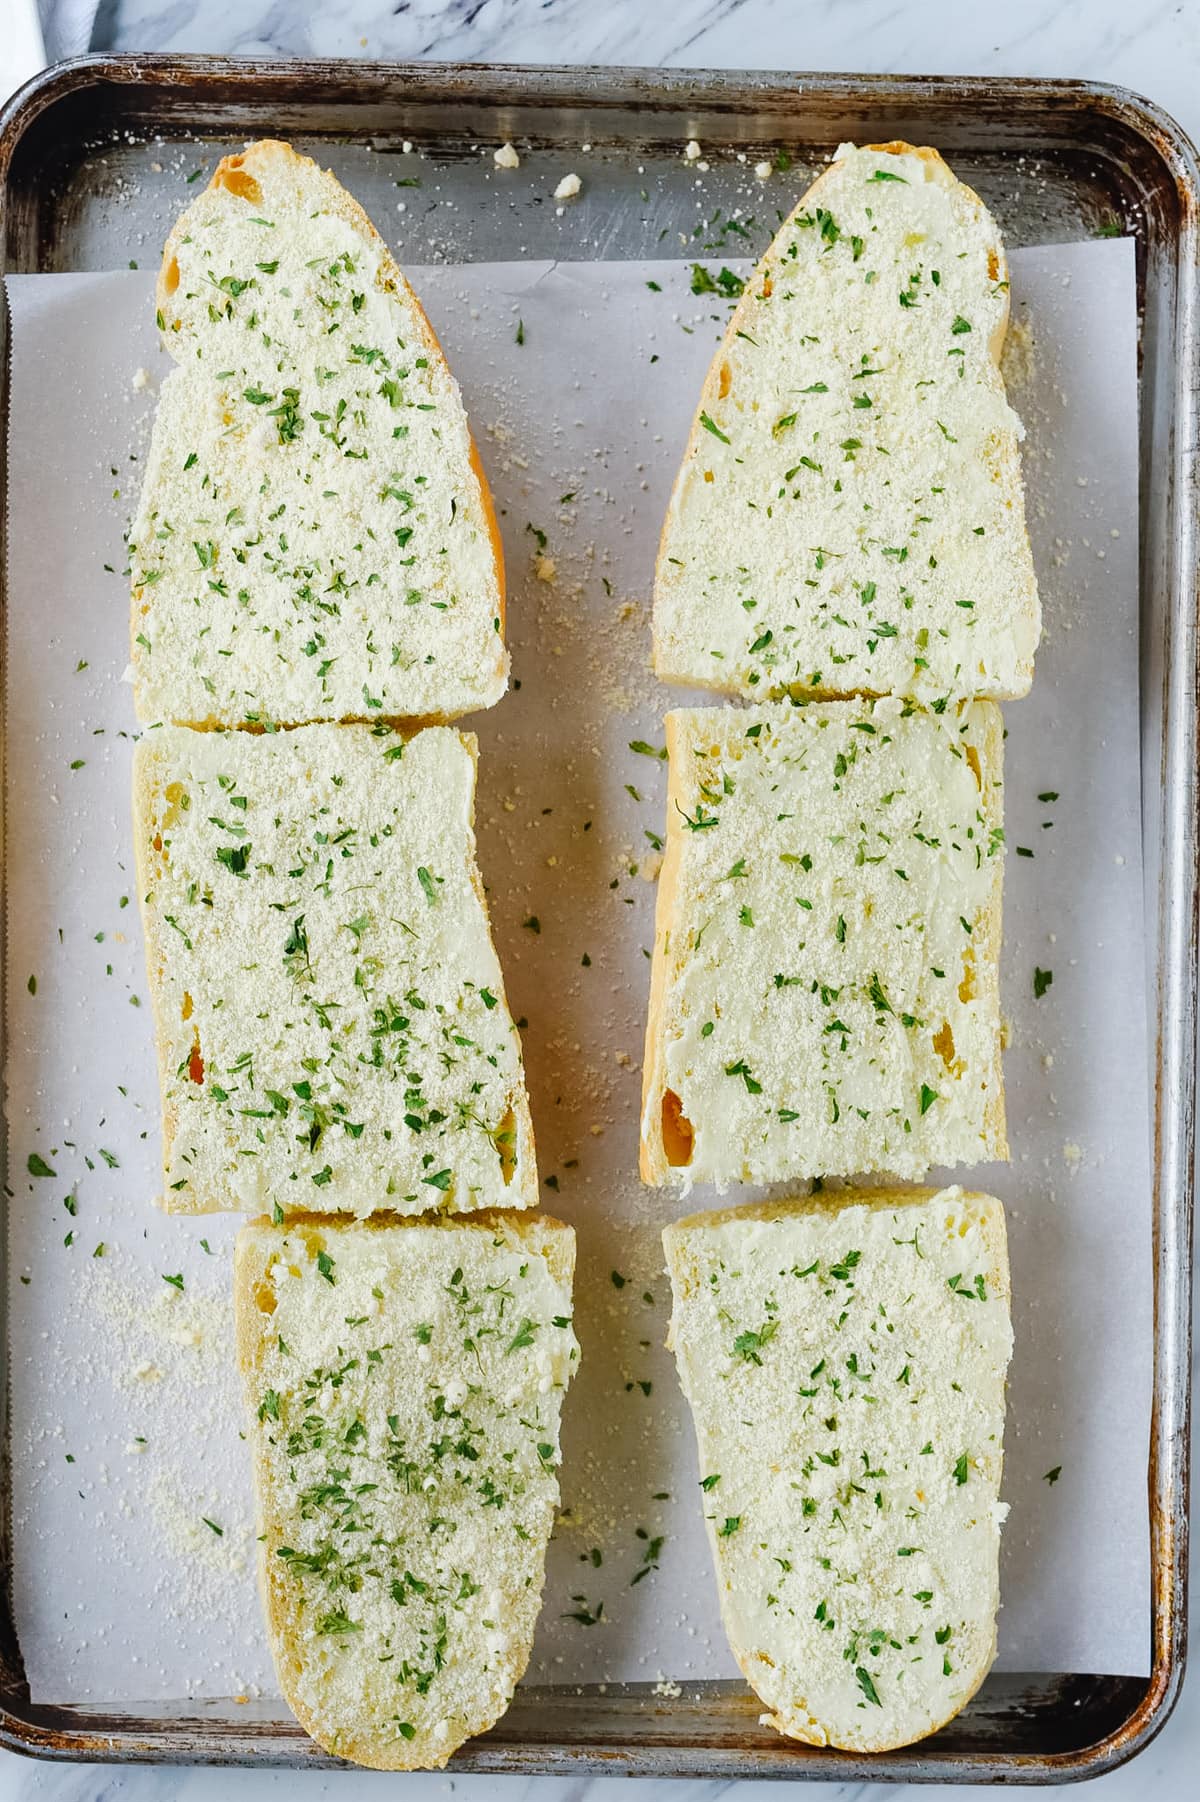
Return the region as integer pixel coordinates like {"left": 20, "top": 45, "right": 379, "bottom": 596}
{"left": 234, "top": 1215, "right": 578, "bottom": 1770}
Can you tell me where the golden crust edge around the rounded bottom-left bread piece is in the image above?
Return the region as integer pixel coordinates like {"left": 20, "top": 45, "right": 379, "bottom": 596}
{"left": 234, "top": 1209, "right": 575, "bottom": 1771}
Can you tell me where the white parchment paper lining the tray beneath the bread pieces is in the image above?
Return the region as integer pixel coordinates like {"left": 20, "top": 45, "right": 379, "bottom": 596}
{"left": 5, "top": 241, "right": 1151, "bottom": 1703}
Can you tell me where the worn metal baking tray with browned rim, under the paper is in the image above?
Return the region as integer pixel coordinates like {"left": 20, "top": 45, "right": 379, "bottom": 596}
{"left": 0, "top": 56, "right": 1200, "bottom": 1784}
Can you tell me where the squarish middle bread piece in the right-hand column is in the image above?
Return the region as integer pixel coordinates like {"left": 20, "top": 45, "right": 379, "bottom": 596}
{"left": 641, "top": 697, "right": 1007, "bottom": 1188}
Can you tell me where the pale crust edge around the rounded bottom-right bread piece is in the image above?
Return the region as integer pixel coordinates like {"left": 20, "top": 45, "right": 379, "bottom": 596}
{"left": 663, "top": 1188, "right": 1013, "bottom": 1753}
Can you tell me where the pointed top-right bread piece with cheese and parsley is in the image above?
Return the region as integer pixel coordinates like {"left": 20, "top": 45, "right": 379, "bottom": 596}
{"left": 654, "top": 144, "right": 1041, "bottom": 701}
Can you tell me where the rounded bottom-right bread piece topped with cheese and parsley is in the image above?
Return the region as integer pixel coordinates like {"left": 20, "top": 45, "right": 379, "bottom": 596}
{"left": 663, "top": 1189, "right": 1013, "bottom": 1752}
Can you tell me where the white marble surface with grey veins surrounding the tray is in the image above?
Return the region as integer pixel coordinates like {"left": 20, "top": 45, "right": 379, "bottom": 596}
{"left": 9, "top": 0, "right": 1200, "bottom": 1802}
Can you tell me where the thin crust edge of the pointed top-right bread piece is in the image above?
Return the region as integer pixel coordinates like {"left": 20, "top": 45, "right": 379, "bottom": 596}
{"left": 652, "top": 139, "right": 1032, "bottom": 701}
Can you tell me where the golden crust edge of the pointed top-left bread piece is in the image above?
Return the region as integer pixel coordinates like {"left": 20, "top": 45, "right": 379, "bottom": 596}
{"left": 130, "top": 139, "right": 508, "bottom": 730}
